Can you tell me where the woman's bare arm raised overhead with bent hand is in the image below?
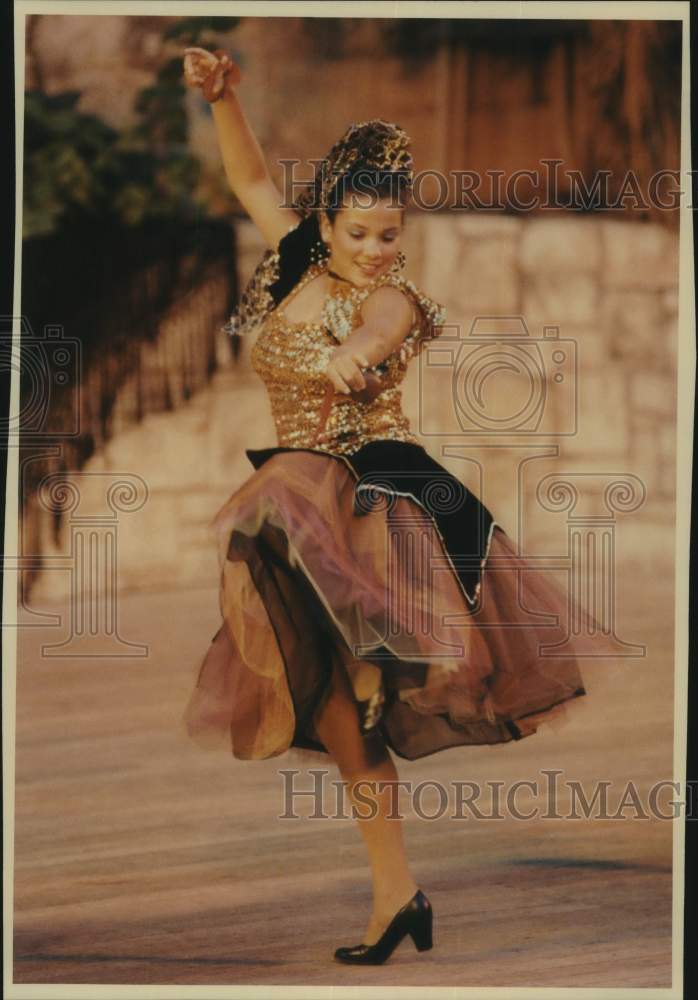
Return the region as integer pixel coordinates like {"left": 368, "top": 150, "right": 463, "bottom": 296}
{"left": 184, "top": 47, "right": 299, "bottom": 250}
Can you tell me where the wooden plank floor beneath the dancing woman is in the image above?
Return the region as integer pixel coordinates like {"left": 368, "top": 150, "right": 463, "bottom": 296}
{"left": 9, "top": 586, "right": 673, "bottom": 988}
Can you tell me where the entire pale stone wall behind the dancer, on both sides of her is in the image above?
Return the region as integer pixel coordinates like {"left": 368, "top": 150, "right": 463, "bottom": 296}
{"left": 32, "top": 214, "right": 677, "bottom": 598}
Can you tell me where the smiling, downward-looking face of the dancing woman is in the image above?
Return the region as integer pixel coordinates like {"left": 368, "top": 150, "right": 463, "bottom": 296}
{"left": 320, "top": 194, "right": 403, "bottom": 287}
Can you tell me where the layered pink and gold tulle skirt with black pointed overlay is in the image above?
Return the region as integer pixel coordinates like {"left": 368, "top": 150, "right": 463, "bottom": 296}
{"left": 184, "top": 440, "right": 595, "bottom": 760}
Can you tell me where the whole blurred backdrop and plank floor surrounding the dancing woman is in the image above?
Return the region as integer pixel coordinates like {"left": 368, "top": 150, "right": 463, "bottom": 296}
{"left": 10, "top": 14, "right": 685, "bottom": 988}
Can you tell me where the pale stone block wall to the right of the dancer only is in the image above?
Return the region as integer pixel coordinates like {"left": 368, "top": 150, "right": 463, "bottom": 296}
{"left": 400, "top": 215, "right": 678, "bottom": 570}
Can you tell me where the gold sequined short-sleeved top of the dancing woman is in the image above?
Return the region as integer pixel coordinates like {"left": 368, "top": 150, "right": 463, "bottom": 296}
{"left": 250, "top": 263, "right": 445, "bottom": 455}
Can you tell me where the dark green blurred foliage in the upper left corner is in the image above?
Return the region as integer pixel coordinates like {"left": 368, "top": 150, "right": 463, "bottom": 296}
{"left": 23, "top": 17, "right": 238, "bottom": 237}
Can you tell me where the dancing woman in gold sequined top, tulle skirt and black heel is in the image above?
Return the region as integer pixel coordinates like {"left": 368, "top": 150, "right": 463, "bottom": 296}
{"left": 179, "top": 48, "right": 585, "bottom": 964}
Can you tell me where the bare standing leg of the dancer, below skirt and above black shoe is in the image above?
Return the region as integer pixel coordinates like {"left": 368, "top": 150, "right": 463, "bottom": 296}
{"left": 315, "top": 659, "right": 417, "bottom": 944}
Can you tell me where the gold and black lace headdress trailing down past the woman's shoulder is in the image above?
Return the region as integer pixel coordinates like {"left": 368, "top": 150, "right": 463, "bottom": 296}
{"left": 223, "top": 118, "right": 413, "bottom": 357}
